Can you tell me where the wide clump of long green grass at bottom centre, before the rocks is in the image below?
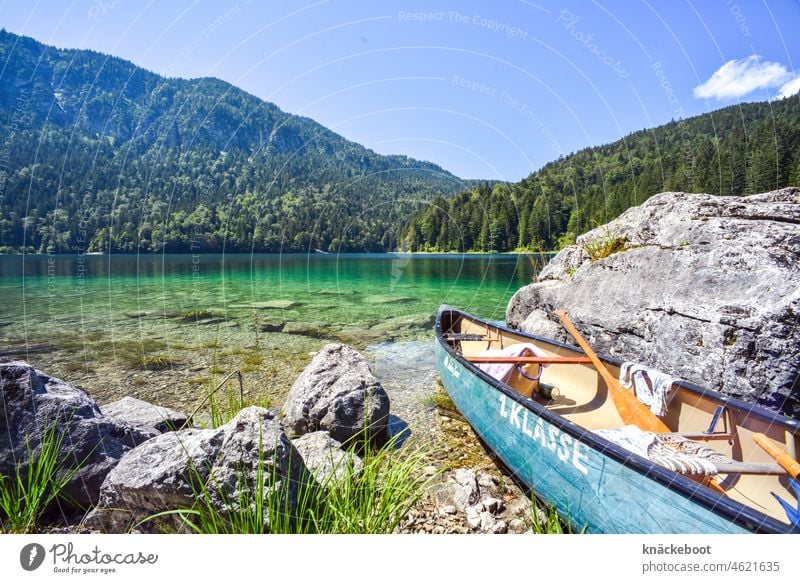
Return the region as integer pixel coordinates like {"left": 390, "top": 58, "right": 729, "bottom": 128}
{"left": 137, "top": 428, "right": 431, "bottom": 534}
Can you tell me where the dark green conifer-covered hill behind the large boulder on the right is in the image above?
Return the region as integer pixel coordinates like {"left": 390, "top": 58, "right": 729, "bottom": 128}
{"left": 403, "top": 95, "right": 800, "bottom": 251}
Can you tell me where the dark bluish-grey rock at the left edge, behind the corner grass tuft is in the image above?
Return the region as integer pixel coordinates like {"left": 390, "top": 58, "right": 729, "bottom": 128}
{"left": 0, "top": 361, "right": 152, "bottom": 511}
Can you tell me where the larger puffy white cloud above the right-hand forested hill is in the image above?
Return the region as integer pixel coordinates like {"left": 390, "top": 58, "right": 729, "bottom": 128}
{"left": 694, "top": 55, "right": 797, "bottom": 101}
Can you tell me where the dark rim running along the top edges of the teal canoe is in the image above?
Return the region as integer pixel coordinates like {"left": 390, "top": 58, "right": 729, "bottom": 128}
{"left": 435, "top": 305, "right": 800, "bottom": 534}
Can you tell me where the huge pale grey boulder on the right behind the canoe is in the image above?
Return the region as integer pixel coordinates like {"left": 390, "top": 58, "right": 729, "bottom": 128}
{"left": 506, "top": 188, "right": 800, "bottom": 416}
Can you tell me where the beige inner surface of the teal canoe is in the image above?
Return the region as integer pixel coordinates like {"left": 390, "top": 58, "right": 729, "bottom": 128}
{"left": 440, "top": 311, "right": 800, "bottom": 524}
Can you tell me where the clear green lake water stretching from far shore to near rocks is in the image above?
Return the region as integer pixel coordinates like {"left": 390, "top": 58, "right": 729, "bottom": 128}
{"left": 0, "top": 253, "right": 549, "bottom": 416}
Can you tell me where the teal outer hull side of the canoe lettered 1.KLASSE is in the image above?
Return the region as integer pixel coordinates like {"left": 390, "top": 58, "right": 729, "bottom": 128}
{"left": 436, "top": 334, "right": 760, "bottom": 534}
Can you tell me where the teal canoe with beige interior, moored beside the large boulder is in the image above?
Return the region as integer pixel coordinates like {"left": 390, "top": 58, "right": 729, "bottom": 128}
{"left": 436, "top": 306, "right": 800, "bottom": 534}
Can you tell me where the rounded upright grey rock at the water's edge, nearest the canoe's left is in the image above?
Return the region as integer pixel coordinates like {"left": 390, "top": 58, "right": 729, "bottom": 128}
{"left": 283, "top": 344, "right": 389, "bottom": 443}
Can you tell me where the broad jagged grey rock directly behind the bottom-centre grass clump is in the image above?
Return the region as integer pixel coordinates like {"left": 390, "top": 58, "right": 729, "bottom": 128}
{"left": 84, "top": 407, "right": 310, "bottom": 533}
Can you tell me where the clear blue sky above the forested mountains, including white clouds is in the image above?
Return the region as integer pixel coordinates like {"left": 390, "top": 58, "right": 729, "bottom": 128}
{"left": 0, "top": 0, "right": 800, "bottom": 180}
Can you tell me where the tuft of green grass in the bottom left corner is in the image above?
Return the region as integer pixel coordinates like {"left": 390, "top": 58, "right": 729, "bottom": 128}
{"left": 0, "top": 424, "right": 77, "bottom": 534}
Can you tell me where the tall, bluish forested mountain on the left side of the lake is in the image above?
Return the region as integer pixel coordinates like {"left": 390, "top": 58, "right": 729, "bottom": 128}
{"left": 0, "top": 30, "right": 473, "bottom": 252}
